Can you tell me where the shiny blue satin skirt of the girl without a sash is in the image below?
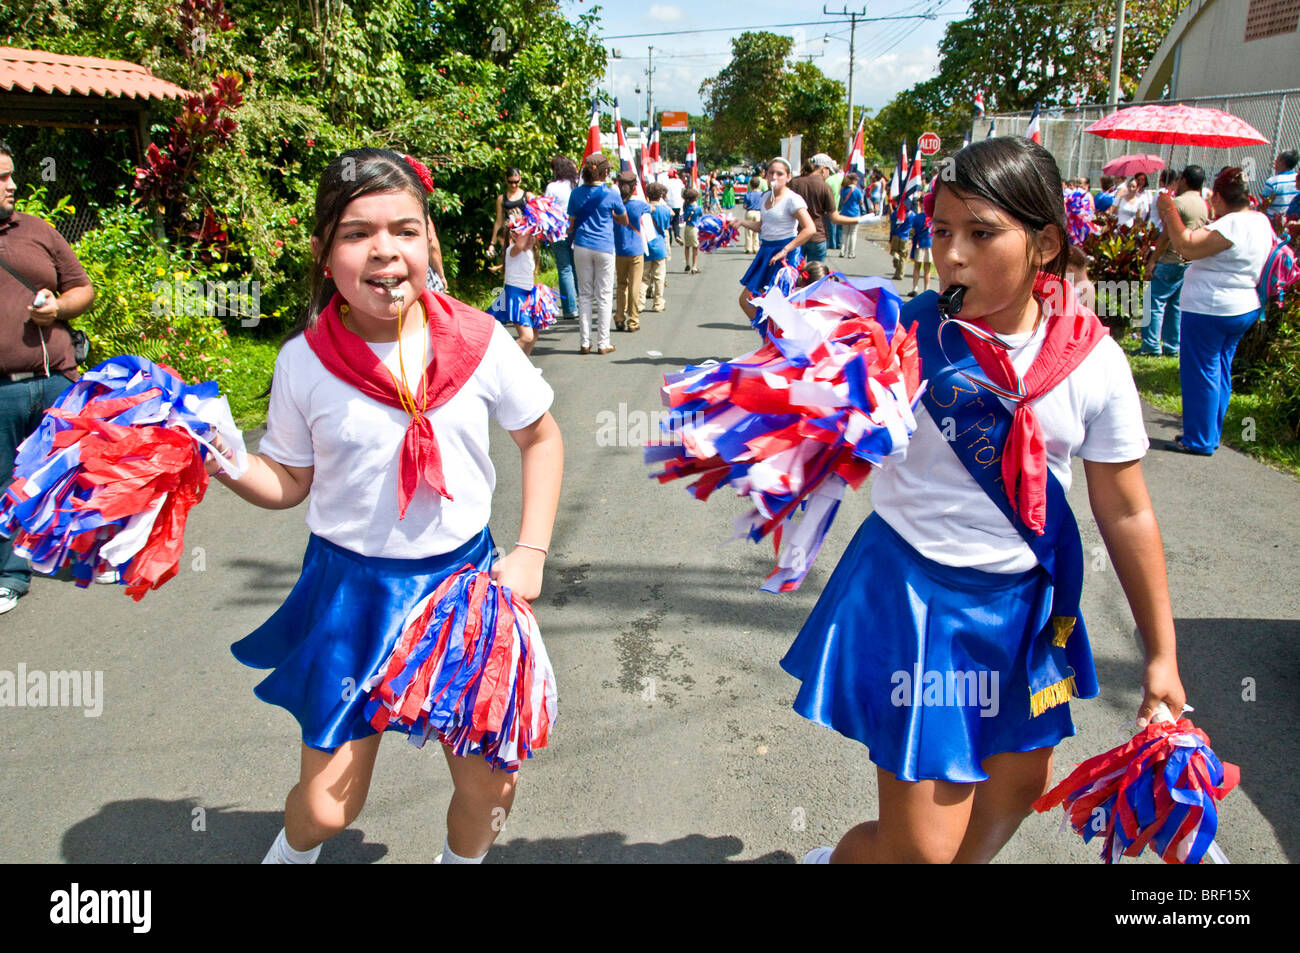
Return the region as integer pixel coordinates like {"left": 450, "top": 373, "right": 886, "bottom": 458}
{"left": 230, "top": 527, "right": 493, "bottom": 751}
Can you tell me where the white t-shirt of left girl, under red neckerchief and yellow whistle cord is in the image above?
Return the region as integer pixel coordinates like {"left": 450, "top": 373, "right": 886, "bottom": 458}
{"left": 259, "top": 324, "right": 554, "bottom": 559}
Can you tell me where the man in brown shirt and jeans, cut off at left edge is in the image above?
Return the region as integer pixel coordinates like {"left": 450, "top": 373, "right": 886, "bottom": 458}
{"left": 0, "top": 140, "right": 95, "bottom": 612}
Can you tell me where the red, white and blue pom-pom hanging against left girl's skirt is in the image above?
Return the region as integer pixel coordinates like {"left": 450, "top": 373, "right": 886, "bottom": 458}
{"left": 361, "top": 566, "right": 556, "bottom": 771}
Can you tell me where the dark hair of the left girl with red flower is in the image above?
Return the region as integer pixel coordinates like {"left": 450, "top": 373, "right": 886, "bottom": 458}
{"left": 286, "top": 148, "right": 429, "bottom": 341}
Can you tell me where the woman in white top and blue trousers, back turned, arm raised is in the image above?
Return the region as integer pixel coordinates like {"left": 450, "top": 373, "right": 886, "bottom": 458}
{"left": 1156, "top": 166, "right": 1273, "bottom": 456}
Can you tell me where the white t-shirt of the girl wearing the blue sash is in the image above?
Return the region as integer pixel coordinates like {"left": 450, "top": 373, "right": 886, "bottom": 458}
{"left": 871, "top": 322, "right": 1149, "bottom": 573}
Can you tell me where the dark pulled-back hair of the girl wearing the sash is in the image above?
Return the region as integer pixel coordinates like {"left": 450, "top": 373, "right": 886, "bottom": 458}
{"left": 937, "top": 135, "right": 1070, "bottom": 278}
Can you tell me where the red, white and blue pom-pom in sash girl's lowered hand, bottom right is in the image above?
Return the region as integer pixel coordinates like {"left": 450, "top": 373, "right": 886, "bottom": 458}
{"left": 1034, "top": 703, "right": 1242, "bottom": 863}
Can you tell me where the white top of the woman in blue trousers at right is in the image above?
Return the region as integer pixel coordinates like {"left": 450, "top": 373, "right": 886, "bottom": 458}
{"left": 1179, "top": 211, "right": 1273, "bottom": 316}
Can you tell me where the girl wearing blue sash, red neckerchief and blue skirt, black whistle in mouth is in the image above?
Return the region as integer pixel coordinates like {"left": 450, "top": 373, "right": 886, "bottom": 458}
{"left": 781, "top": 137, "right": 1184, "bottom": 863}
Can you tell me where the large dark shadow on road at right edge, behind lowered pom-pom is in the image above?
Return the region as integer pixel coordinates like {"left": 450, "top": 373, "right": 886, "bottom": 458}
{"left": 1097, "top": 619, "right": 1300, "bottom": 863}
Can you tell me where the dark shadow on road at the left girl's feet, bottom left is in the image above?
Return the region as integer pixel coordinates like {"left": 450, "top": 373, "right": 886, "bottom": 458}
{"left": 60, "top": 798, "right": 389, "bottom": 863}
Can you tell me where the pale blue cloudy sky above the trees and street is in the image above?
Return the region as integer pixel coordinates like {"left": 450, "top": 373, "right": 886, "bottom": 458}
{"left": 566, "top": 0, "right": 969, "bottom": 121}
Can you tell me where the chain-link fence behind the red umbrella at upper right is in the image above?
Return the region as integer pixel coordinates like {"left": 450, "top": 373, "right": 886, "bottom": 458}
{"left": 974, "top": 88, "right": 1300, "bottom": 192}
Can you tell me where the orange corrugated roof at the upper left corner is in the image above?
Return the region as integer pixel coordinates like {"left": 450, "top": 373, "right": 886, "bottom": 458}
{"left": 0, "top": 47, "right": 191, "bottom": 99}
